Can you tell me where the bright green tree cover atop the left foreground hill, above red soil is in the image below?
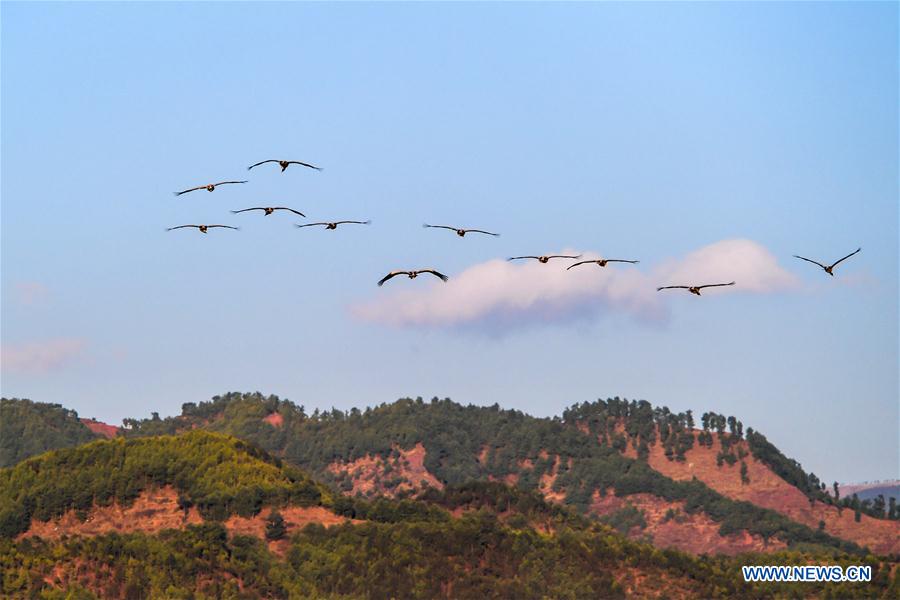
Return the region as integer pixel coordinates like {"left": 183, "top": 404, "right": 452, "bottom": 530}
{"left": 0, "top": 430, "right": 328, "bottom": 537}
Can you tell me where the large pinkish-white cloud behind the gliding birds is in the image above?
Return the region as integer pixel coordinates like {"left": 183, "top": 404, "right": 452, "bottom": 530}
{"left": 351, "top": 240, "right": 796, "bottom": 330}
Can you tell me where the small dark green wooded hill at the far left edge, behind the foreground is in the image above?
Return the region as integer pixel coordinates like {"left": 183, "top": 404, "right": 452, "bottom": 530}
{"left": 0, "top": 398, "right": 98, "bottom": 467}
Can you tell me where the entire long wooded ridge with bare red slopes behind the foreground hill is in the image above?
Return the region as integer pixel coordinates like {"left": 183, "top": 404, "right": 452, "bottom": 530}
{"left": 3, "top": 393, "right": 900, "bottom": 554}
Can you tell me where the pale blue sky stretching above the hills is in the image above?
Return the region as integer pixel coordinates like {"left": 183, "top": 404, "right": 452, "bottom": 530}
{"left": 0, "top": 2, "right": 900, "bottom": 481}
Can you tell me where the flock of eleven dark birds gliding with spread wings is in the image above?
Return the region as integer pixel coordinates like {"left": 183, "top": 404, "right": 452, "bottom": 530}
{"left": 166, "top": 158, "right": 862, "bottom": 296}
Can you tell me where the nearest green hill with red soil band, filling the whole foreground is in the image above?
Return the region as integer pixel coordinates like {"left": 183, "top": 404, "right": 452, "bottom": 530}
{"left": 0, "top": 430, "right": 898, "bottom": 598}
